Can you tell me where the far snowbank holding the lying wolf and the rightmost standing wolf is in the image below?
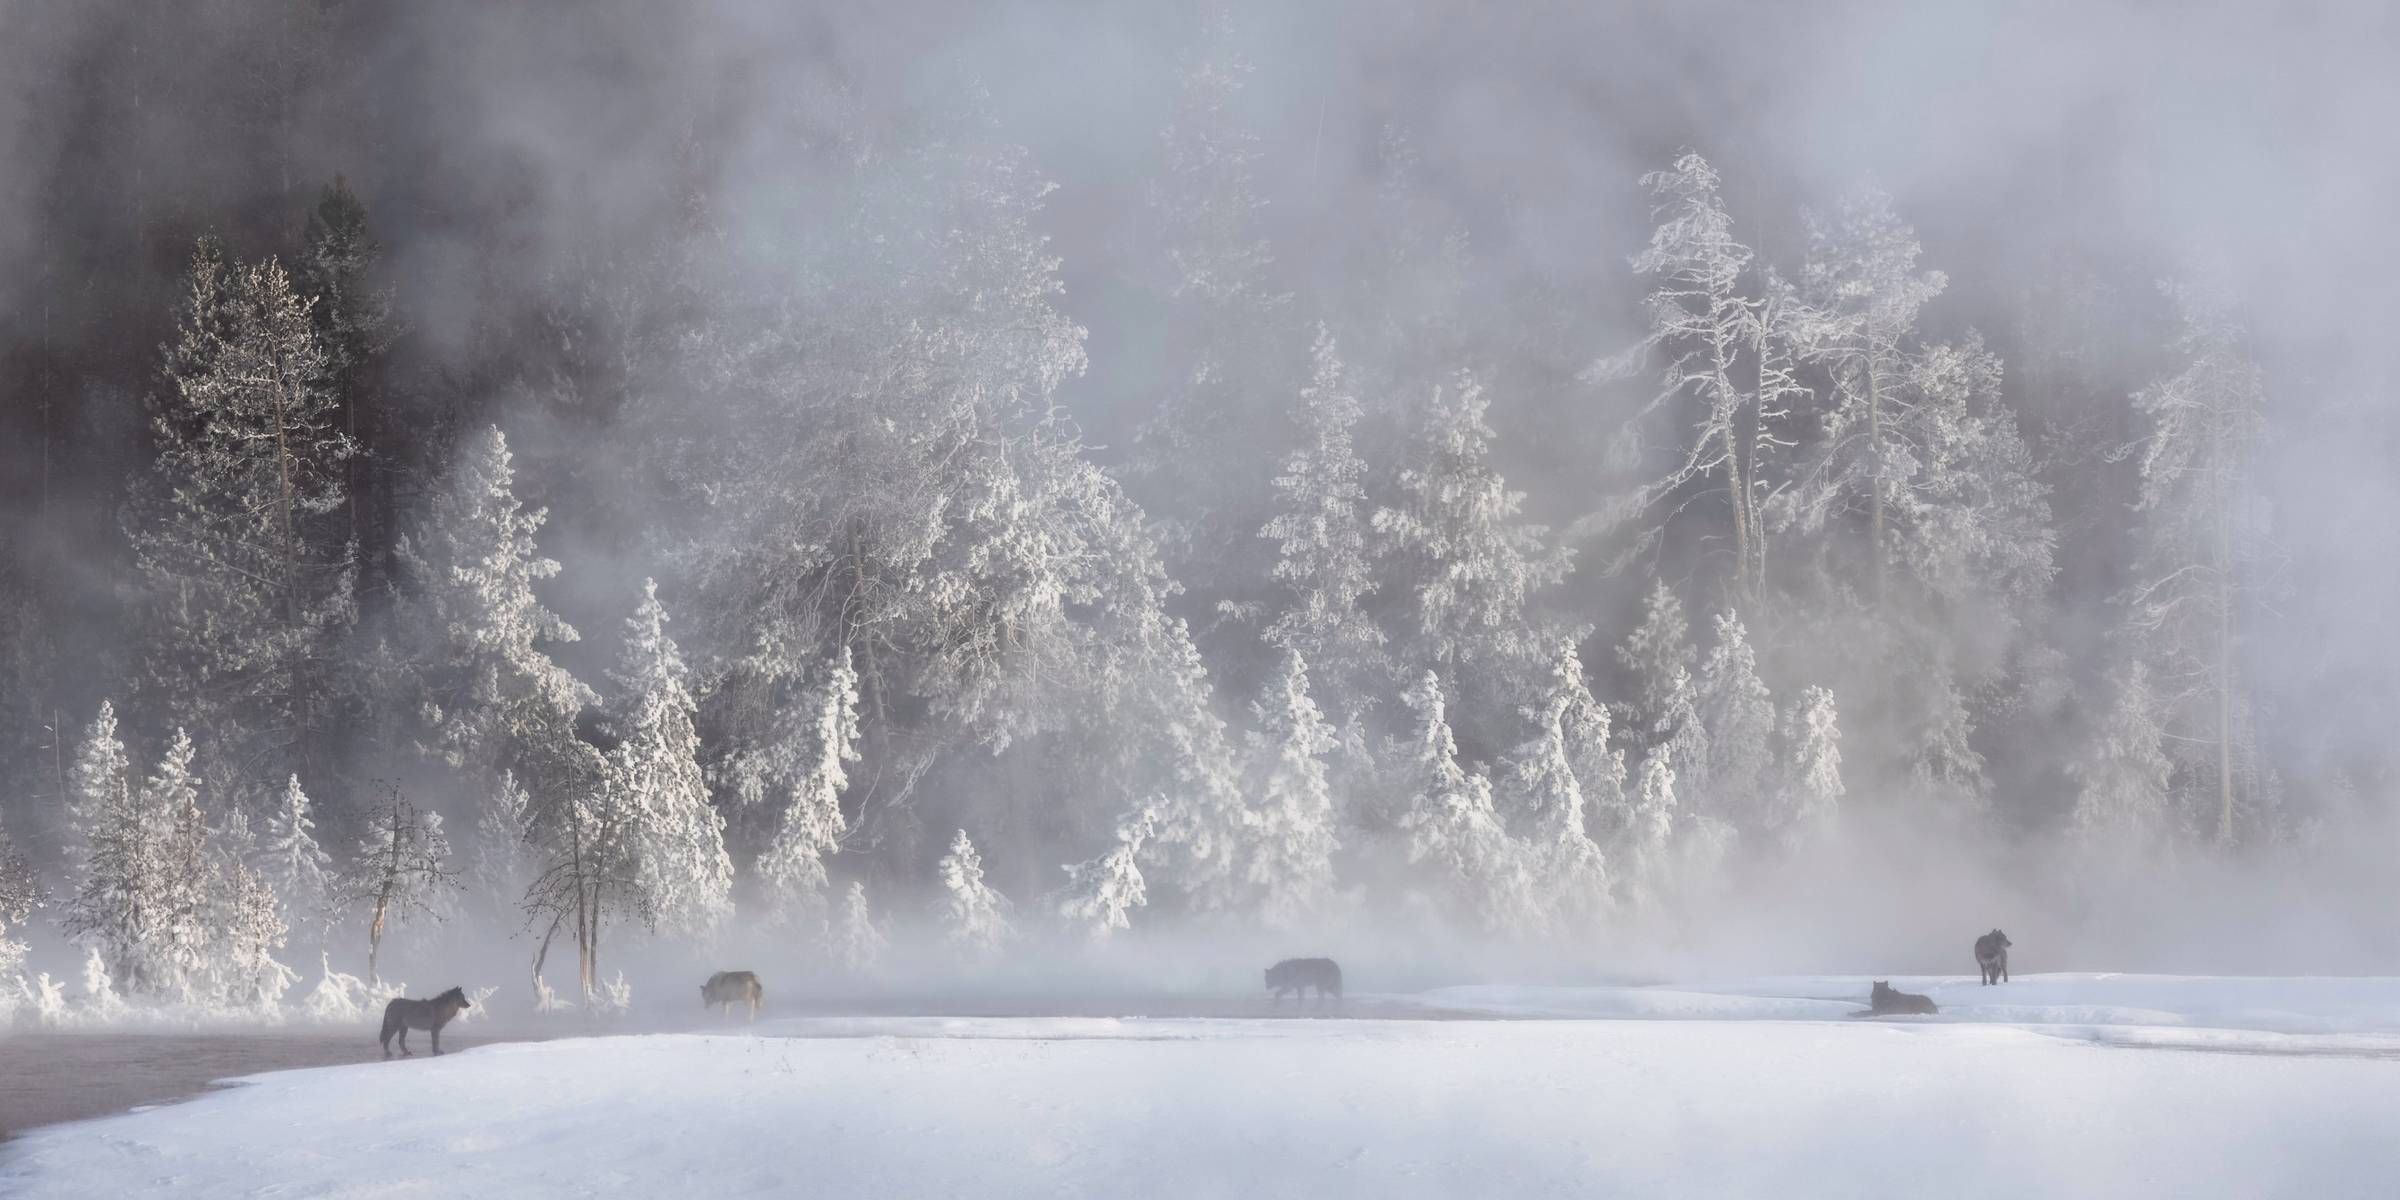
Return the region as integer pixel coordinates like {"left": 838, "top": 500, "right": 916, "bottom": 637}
{"left": 1385, "top": 974, "right": 2400, "bottom": 1034}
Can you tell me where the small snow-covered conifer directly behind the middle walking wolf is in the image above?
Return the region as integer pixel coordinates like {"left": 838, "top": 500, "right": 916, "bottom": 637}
{"left": 1248, "top": 653, "right": 1337, "bottom": 929}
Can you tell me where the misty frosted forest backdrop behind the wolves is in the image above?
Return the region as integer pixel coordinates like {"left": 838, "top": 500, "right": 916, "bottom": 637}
{"left": 0, "top": 0, "right": 2400, "bottom": 1025}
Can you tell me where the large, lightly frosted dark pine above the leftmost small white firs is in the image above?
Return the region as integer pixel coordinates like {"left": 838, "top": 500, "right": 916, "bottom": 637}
{"left": 127, "top": 238, "right": 358, "bottom": 782}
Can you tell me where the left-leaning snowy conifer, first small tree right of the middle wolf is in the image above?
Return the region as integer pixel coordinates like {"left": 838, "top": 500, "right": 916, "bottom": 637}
{"left": 1399, "top": 672, "right": 1538, "bottom": 934}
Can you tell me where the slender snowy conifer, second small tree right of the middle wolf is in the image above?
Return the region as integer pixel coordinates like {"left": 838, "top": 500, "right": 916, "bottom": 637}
{"left": 1507, "top": 641, "right": 1625, "bottom": 934}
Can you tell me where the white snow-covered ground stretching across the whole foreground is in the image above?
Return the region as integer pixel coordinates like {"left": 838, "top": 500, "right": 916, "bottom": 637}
{"left": 0, "top": 977, "right": 2400, "bottom": 1200}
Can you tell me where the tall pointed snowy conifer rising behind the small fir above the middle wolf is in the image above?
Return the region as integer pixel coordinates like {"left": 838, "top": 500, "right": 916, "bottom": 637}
{"left": 1260, "top": 324, "right": 1385, "bottom": 722}
